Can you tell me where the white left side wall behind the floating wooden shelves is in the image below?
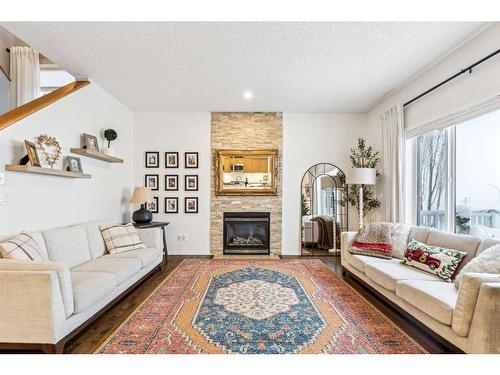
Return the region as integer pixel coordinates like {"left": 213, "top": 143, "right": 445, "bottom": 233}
{"left": 0, "top": 83, "right": 133, "bottom": 235}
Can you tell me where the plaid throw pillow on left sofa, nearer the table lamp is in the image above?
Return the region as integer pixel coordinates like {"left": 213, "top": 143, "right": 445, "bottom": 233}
{"left": 99, "top": 223, "right": 146, "bottom": 254}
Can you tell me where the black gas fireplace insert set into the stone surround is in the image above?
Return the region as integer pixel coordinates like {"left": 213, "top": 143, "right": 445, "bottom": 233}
{"left": 223, "top": 212, "right": 271, "bottom": 254}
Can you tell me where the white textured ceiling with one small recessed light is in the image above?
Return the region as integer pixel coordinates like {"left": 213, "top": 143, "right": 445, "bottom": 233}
{"left": 3, "top": 22, "right": 485, "bottom": 112}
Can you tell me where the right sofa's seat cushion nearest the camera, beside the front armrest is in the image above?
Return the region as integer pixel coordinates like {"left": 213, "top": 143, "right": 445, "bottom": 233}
{"left": 396, "top": 280, "right": 458, "bottom": 326}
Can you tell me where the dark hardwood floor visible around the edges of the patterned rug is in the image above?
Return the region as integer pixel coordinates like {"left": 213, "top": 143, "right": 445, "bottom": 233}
{"left": 0, "top": 256, "right": 449, "bottom": 354}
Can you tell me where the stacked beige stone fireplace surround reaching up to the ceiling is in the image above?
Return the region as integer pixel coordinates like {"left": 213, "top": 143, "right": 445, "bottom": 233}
{"left": 210, "top": 112, "right": 283, "bottom": 255}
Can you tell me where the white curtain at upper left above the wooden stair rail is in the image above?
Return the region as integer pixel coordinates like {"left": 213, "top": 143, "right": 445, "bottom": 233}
{"left": 10, "top": 47, "right": 40, "bottom": 108}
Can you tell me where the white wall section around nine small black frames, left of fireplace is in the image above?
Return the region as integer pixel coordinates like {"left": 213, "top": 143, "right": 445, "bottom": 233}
{"left": 134, "top": 112, "right": 211, "bottom": 255}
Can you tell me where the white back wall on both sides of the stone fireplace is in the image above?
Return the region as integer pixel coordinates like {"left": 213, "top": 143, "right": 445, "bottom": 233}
{"left": 134, "top": 113, "right": 381, "bottom": 255}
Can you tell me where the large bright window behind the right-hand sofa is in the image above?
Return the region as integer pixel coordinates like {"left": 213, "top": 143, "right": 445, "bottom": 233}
{"left": 409, "top": 110, "right": 500, "bottom": 237}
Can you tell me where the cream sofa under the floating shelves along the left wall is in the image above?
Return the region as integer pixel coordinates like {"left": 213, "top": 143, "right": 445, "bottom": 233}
{"left": 0, "top": 221, "right": 163, "bottom": 352}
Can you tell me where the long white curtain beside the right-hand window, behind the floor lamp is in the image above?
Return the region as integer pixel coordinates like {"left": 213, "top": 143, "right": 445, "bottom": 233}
{"left": 382, "top": 106, "right": 405, "bottom": 223}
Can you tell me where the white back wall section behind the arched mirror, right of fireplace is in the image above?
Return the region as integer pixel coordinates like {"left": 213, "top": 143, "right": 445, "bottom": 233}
{"left": 282, "top": 113, "right": 381, "bottom": 255}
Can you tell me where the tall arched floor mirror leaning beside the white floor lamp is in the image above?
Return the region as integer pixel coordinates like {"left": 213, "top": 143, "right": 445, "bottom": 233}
{"left": 300, "top": 163, "right": 348, "bottom": 256}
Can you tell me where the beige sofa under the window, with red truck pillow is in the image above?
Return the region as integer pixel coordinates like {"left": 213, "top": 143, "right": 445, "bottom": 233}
{"left": 341, "top": 227, "right": 500, "bottom": 353}
